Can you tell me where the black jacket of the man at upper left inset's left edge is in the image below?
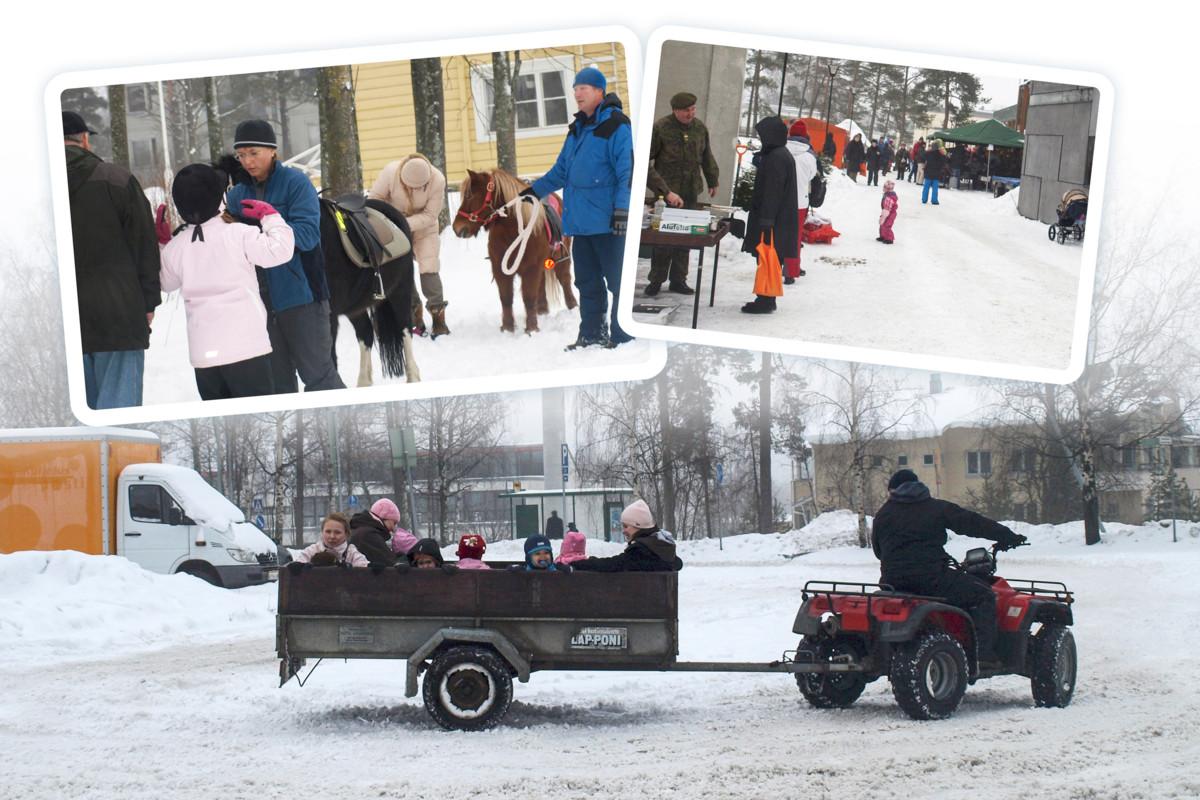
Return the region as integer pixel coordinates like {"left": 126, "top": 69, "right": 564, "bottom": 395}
{"left": 66, "top": 145, "right": 162, "bottom": 353}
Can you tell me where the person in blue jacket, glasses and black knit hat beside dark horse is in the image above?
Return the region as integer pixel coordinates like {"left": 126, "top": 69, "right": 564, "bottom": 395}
{"left": 226, "top": 120, "right": 346, "bottom": 393}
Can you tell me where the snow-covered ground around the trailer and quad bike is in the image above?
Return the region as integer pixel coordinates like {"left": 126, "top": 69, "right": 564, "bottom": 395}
{"left": 0, "top": 512, "right": 1200, "bottom": 800}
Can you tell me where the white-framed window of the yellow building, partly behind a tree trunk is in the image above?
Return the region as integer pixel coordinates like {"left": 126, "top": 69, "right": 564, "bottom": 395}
{"left": 470, "top": 58, "right": 575, "bottom": 142}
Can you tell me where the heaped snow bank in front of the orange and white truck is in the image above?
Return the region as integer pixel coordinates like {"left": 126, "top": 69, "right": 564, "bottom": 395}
{"left": 0, "top": 551, "right": 276, "bottom": 663}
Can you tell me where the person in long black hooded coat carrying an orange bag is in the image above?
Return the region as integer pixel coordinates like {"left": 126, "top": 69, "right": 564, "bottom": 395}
{"left": 742, "top": 116, "right": 800, "bottom": 314}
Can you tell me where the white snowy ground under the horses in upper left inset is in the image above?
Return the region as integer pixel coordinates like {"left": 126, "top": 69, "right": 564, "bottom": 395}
{"left": 144, "top": 215, "right": 660, "bottom": 405}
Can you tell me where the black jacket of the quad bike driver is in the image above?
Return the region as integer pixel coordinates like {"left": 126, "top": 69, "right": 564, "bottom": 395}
{"left": 871, "top": 481, "right": 1019, "bottom": 583}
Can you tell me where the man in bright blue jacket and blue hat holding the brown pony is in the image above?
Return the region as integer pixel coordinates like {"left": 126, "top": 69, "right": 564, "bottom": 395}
{"left": 524, "top": 67, "right": 634, "bottom": 350}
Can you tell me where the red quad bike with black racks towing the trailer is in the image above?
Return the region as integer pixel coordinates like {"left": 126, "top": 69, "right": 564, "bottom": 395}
{"left": 785, "top": 545, "right": 1076, "bottom": 720}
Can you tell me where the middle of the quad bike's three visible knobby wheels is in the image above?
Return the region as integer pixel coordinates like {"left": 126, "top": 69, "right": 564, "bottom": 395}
{"left": 888, "top": 630, "right": 967, "bottom": 720}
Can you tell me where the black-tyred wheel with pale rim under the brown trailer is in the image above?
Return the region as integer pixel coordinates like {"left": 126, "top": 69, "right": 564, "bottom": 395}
{"left": 421, "top": 645, "right": 512, "bottom": 730}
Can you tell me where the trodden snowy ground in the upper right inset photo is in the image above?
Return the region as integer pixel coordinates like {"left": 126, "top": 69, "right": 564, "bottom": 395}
{"left": 634, "top": 170, "right": 1082, "bottom": 369}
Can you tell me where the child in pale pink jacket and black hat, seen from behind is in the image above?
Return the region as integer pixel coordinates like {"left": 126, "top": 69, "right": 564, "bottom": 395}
{"left": 160, "top": 164, "right": 295, "bottom": 399}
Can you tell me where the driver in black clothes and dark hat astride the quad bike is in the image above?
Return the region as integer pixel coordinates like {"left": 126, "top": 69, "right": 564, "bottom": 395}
{"left": 871, "top": 469, "right": 1026, "bottom": 662}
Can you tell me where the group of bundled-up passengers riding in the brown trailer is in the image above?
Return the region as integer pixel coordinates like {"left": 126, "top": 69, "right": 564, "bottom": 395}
{"left": 295, "top": 498, "right": 683, "bottom": 572}
